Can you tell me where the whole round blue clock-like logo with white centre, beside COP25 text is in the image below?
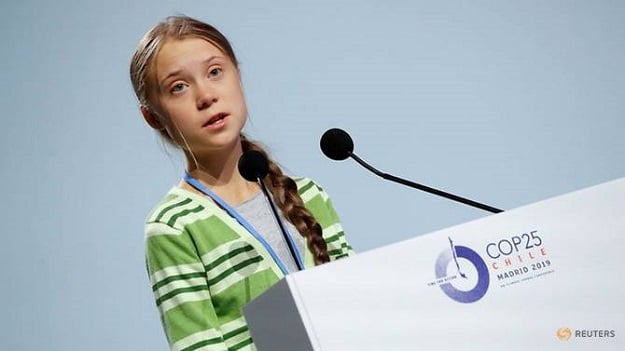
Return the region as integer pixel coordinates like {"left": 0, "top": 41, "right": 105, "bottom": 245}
{"left": 435, "top": 238, "right": 490, "bottom": 303}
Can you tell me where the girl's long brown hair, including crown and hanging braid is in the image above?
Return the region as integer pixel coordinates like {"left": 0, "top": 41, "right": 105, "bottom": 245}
{"left": 130, "top": 16, "right": 330, "bottom": 264}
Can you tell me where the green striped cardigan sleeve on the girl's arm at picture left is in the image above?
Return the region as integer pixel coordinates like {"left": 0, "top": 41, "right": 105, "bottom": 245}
{"left": 146, "top": 221, "right": 228, "bottom": 351}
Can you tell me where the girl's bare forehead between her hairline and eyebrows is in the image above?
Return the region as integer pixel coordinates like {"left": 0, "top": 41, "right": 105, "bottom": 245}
{"left": 154, "top": 38, "right": 226, "bottom": 79}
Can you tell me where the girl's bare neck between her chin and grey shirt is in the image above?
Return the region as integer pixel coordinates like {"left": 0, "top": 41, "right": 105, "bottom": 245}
{"left": 181, "top": 141, "right": 260, "bottom": 205}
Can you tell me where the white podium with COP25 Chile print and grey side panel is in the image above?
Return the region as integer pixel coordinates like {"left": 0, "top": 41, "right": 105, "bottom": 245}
{"left": 244, "top": 178, "right": 625, "bottom": 351}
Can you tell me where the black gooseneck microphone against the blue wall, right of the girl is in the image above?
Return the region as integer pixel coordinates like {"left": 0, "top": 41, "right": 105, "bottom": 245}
{"left": 320, "top": 128, "right": 503, "bottom": 213}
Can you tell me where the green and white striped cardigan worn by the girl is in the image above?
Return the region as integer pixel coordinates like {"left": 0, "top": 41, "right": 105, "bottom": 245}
{"left": 145, "top": 178, "right": 353, "bottom": 351}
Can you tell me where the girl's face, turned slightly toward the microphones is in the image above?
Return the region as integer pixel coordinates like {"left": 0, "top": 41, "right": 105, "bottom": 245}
{"left": 152, "top": 38, "right": 247, "bottom": 155}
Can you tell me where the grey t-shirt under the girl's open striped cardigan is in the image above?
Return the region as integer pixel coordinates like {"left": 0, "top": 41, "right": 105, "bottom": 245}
{"left": 234, "top": 191, "right": 306, "bottom": 272}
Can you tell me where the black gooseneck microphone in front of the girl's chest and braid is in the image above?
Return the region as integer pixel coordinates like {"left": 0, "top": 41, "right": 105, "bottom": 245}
{"left": 237, "top": 150, "right": 304, "bottom": 271}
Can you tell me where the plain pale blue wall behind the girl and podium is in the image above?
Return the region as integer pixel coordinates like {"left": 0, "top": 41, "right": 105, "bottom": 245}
{"left": 0, "top": 0, "right": 625, "bottom": 350}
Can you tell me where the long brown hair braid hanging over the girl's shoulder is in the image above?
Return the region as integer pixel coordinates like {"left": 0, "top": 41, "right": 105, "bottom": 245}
{"left": 241, "top": 135, "right": 330, "bottom": 265}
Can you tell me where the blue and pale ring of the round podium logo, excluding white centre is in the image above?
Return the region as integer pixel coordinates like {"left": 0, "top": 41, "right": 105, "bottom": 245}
{"left": 435, "top": 243, "right": 490, "bottom": 303}
